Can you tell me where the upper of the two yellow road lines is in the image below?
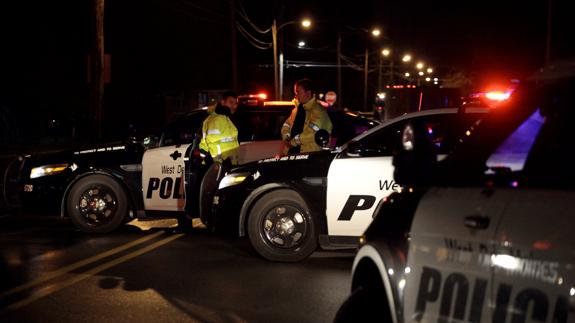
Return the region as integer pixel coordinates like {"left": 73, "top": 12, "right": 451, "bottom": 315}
{"left": 0, "top": 231, "right": 164, "bottom": 299}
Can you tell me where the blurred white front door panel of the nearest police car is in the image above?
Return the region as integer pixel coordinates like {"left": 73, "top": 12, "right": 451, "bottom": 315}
{"left": 405, "top": 186, "right": 509, "bottom": 322}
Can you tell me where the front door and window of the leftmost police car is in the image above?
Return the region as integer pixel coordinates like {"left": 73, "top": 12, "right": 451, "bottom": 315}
{"left": 142, "top": 111, "right": 207, "bottom": 212}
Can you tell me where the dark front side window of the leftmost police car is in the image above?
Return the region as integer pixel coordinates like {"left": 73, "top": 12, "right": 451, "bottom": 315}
{"left": 160, "top": 111, "right": 208, "bottom": 147}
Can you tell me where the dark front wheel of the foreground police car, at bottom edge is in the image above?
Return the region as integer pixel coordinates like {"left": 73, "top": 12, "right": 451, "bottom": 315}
{"left": 334, "top": 287, "right": 392, "bottom": 323}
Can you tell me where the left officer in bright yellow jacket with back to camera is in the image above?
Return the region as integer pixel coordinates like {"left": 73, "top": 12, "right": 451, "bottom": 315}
{"left": 200, "top": 91, "right": 240, "bottom": 165}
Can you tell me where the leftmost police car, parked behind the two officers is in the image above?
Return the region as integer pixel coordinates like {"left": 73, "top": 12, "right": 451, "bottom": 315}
{"left": 3, "top": 96, "right": 376, "bottom": 232}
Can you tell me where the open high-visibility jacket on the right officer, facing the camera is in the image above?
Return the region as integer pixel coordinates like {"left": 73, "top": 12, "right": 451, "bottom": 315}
{"left": 281, "top": 97, "right": 333, "bottom": 154}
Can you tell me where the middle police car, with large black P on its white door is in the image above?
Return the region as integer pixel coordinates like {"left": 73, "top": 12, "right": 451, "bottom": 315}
{"left": 206, "top": 108, "right": 489, "bottom": 261}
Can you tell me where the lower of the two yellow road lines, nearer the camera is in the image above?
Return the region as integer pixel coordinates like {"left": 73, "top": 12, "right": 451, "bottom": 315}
{"left": 5, "top": 233, "right": 184, "bottom": 312}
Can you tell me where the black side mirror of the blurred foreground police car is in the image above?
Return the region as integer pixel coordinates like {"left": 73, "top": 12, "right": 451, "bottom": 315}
{"left": 393, "top": 122, "right": 437, "bottom": 187}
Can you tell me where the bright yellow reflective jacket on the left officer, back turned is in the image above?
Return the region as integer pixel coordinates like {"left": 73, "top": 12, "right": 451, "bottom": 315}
{"left": 200, "top": 109, "right": 240, "bottom": 165}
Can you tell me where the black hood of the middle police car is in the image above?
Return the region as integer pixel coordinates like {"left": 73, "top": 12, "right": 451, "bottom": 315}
{"left": 229, "top": 150, "right": 337, "bottom": 181}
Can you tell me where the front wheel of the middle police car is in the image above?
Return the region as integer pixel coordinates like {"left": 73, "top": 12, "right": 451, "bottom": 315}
{"left": 247, "top": 189, "right": 317, "bottom": 262}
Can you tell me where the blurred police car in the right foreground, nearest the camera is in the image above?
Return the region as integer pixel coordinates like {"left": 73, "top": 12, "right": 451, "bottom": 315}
{"left": 336, "top": 61, "right": 575, "bottom": 322}
